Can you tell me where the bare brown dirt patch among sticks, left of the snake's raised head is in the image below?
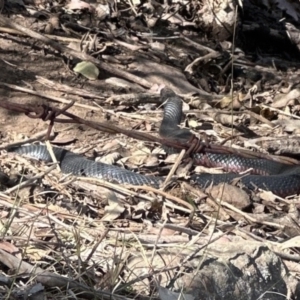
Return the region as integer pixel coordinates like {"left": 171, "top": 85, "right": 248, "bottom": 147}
{"left": 0, "top": 27, "right": 151, "bottom": 155}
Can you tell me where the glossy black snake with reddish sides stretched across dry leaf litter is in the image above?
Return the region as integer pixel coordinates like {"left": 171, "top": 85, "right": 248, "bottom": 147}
{"left": 10, "top": 89, "right": 300, "bottom": 197}
